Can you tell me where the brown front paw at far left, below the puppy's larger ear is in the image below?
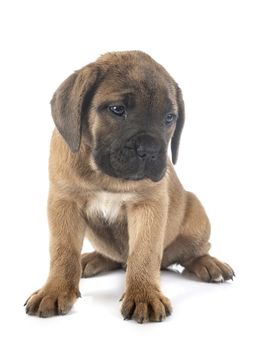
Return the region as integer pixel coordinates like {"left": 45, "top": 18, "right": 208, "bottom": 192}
{"left": 24, "top": 284, "right": 80, "bottom": 317}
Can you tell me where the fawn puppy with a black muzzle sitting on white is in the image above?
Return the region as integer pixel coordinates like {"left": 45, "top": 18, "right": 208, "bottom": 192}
{"left": 26, "top": 51, "right": 234, "bottom": 323}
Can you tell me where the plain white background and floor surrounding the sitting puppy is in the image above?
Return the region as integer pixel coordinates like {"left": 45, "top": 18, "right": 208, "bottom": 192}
{"left": 0, "top": 0, "right": 257, "bottom": 350}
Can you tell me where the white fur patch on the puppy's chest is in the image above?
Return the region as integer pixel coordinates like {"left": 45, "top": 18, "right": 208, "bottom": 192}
{"left": 87, "top": 191, "right": 132, "bottom": 222}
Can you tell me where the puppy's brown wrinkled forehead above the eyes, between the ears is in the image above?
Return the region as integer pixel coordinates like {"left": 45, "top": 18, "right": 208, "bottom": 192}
{"left": 94, "top": 64, "right": 177, "bottom": 110}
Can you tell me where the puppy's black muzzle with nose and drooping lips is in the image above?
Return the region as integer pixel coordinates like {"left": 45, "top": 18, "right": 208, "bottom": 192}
{"left": 93, "top": 133, "right": 167, "bottom": 182}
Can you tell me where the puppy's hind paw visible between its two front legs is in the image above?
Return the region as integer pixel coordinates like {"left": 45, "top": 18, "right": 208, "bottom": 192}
{"left": 81, "top": 251, "right": 122, "bottom": 278}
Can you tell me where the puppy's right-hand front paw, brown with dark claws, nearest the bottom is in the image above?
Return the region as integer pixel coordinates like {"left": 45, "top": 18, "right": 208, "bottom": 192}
{"left": 121, "top": 286, "right": 172, "bottom": 323}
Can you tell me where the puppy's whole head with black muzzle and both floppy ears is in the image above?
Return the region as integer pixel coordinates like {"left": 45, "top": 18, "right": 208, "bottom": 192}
{"left": 51, "top": 51, "right": 184, "bottom": 181}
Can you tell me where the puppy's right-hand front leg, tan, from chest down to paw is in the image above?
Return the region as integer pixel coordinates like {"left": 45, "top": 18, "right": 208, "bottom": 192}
{"left": 121, "top": 201, "right": 171, "bottom": 323}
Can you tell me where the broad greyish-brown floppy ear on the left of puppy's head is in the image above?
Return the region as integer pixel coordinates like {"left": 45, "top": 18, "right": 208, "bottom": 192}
{"left": 51, "top": 64, "right": 98, "bottom": 152}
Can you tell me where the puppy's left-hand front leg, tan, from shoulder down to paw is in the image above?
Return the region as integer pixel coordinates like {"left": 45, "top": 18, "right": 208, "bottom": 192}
{"left": 26, "top": 194, "right": 85, "bottom": 317}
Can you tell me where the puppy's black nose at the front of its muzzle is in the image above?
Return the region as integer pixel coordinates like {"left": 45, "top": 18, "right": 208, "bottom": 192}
{"left": 136, "top": 135, "right": 161, "bottom": 160}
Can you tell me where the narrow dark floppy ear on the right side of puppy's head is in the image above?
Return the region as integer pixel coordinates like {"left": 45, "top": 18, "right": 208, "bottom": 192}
{"left": 171, "top": 86, "right": 185, "bottom": 164}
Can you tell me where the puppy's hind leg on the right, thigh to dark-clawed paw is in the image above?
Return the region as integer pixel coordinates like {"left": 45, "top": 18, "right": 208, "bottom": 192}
{"left": 161, "top": 192, "right": 234, "bottom": 282}
